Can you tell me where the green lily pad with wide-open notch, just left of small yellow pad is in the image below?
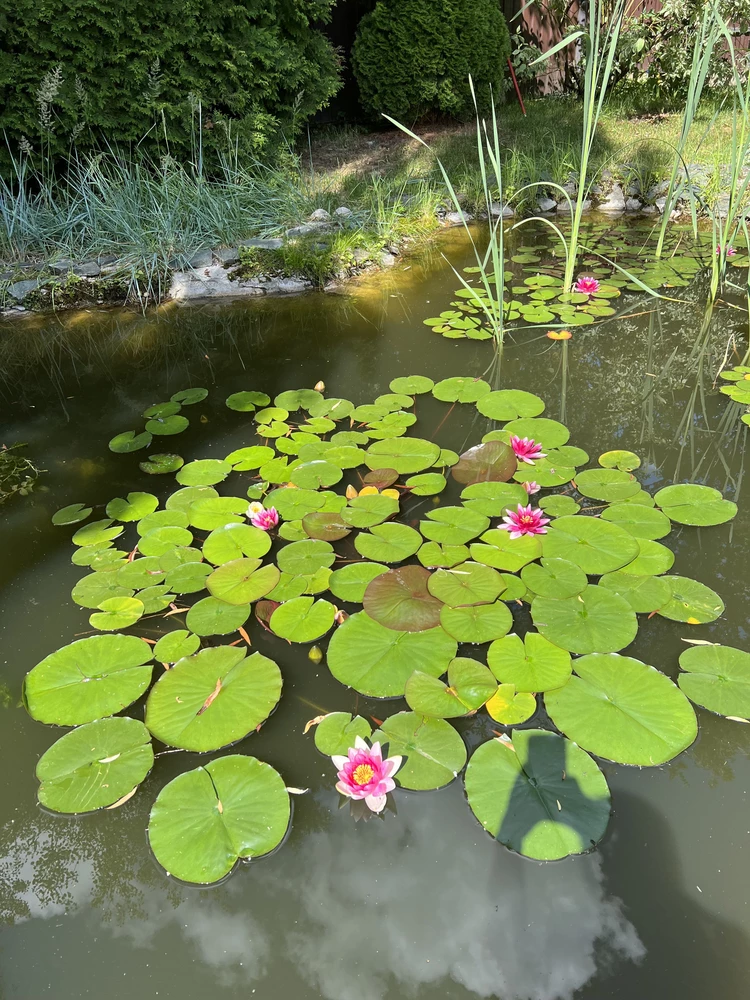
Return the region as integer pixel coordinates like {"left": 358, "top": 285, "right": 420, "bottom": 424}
{"left": 405, "top": 656, "right": 497, "bottom": 719}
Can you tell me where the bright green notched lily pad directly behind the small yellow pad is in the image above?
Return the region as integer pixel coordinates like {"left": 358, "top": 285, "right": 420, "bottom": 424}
{"left": 487, "top": 632, "right": 572, "bottom": 692}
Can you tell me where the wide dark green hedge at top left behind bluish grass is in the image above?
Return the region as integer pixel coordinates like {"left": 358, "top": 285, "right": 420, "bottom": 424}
{"left": 0, "top": 0, "right": 338, "bottom": 163}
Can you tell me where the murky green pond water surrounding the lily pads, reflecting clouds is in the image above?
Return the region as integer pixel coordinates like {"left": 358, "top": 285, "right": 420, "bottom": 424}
{"left": 0, "top": 227, "right": 750, "bottom": 1000}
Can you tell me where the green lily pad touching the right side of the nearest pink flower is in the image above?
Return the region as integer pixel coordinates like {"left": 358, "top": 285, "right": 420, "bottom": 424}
{"left": 372, "top": 712, "right": 466, "bottom": 791}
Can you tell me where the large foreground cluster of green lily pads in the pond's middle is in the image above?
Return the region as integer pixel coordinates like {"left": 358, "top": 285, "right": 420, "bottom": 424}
{"left": 24, "top": 376, "right": 750, "bottom": 884}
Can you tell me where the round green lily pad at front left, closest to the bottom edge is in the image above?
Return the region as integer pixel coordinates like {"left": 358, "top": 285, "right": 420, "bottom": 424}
{"left": 148, "top": 754, "right": 291, "bottom": 885}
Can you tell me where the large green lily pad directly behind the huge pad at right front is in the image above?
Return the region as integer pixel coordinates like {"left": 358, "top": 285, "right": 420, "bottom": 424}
{"left": 531, "top": 586, "right": 638, "bottom": 653}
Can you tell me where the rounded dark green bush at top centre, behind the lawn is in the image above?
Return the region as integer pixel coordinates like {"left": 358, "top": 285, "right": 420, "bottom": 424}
{"left": 352, "top": 0, "right": 510, "bottom": 123}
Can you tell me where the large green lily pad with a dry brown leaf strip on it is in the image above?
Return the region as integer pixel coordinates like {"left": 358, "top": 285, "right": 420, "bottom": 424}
{"left": 146, "top": 646, "right": 282, "bottom": 753}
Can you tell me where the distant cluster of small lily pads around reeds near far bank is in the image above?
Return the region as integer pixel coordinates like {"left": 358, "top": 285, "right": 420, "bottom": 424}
{"left": 424, "top": 223, "right": 749, "bottom": 340}
